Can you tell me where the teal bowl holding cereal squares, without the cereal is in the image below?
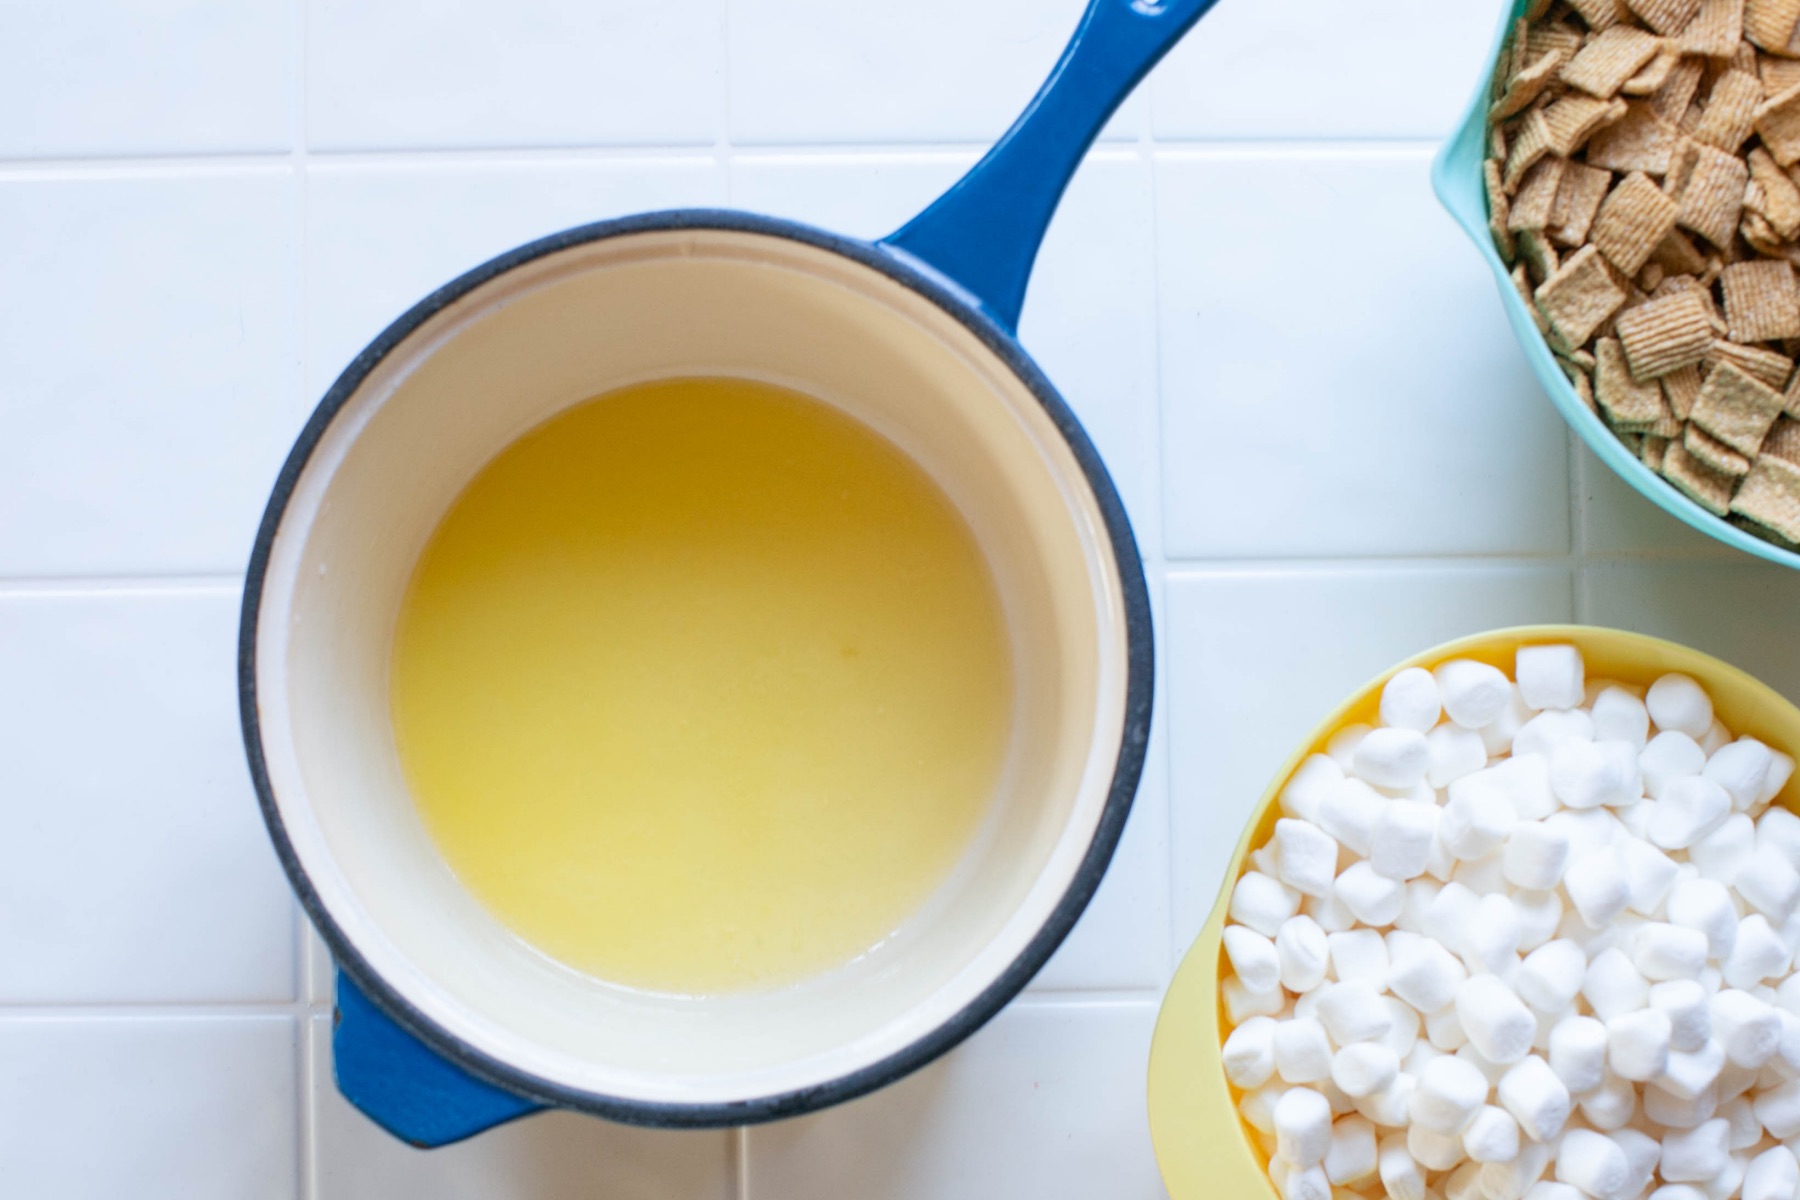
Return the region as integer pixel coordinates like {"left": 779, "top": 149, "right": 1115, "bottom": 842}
{"left": 1431, "top": 0, "right": 1800, "bottom": 570}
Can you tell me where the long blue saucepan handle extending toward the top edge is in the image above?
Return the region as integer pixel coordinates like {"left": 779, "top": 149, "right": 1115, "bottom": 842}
{"left": 880, "top": 0, "right": 1219, "bottom": 333}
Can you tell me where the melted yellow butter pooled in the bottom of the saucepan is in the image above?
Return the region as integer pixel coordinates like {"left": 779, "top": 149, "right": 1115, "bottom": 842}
{"left": 392, "top": 380, "right": 1013, "bottom": 993}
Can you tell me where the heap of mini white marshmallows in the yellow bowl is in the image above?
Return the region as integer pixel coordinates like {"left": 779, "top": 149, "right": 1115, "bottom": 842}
{"left": 1222, "top": 646, "right": 1800, "bottom": 1200}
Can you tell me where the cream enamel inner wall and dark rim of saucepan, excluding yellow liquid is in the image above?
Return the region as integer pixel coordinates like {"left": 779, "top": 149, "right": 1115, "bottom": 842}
{"left": 239, "top": 212, "right": 1150, "bottom": 1124}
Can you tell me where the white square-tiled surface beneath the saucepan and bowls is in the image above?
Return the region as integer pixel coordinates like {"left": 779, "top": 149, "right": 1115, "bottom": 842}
{"left": 0, "top": 0, "right": 1800, "bottom": 1200}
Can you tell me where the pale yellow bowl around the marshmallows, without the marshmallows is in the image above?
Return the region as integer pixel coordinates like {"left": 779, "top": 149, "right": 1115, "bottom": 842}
{"left": 1150, "top": 624, "right": 1800, "bottom": 1200}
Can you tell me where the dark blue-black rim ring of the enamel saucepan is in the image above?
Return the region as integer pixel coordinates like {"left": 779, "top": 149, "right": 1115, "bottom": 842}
{"left": 238, "top": 209, "right": 1156, "bottom": 1128}
